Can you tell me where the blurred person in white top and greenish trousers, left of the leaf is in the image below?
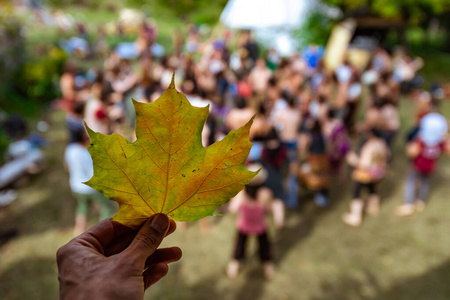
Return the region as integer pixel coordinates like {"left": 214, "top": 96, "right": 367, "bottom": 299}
{"left": 64, "top": 129, "right": 112, "bottom": 235}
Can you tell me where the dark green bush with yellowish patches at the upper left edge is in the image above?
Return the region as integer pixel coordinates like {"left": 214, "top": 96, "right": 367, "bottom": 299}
{"left": 0, "top": 7, "right": 66, "bottom": 117}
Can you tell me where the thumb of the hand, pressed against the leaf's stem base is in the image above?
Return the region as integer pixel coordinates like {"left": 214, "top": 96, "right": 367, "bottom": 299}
{"left": 123, "top": 213, "right": 170, "bottom": 265}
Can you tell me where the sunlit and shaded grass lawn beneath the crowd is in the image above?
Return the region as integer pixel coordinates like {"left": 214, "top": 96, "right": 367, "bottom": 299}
{"left": 0, "top": 64, "right": 450, "bottom": 300}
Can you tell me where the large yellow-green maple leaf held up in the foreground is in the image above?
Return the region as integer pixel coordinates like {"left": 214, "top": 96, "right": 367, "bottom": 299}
{"left": 86, "top": 79, "right": 257, "bottom": 228}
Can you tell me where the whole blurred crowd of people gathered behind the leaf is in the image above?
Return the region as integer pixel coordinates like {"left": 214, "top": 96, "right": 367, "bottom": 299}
{"left": 60, "top": 23, "right": 450, "bottom": 278}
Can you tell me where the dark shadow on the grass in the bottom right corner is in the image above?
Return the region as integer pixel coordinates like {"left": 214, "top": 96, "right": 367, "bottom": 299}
{"left": 312, "top": 260, "right": 450, "bottom": 300}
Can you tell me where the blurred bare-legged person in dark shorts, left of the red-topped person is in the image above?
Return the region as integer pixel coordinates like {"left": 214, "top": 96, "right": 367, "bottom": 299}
{"left": 342, "top": 128, "right": 389, "bottom": 226}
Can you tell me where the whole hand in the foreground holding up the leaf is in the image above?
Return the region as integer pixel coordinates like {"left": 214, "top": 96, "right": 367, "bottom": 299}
{"left": 57, "top": 214, "right": 181, "bottom": 300}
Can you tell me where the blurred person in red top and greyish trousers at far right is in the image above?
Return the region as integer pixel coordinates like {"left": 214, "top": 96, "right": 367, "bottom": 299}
{"left": 395, "top": 113, "right": 450, "bottom": 216}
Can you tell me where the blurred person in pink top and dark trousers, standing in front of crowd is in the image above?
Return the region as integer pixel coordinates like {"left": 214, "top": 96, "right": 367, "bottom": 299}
{"left": 227, "top": 164, "right": 284, "bottom": 280}
